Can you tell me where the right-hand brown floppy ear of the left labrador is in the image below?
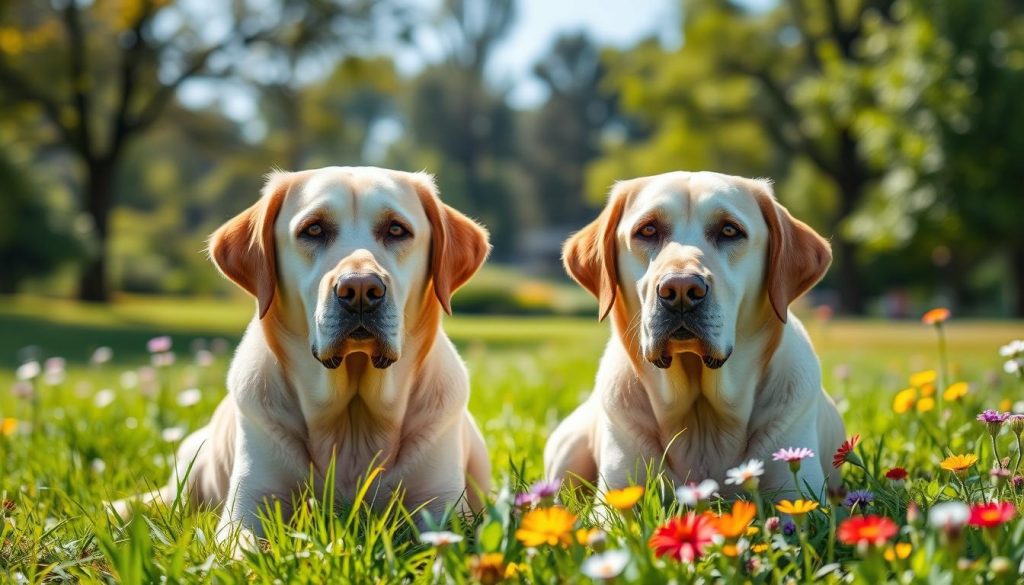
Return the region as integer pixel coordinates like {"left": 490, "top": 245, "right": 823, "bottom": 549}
{"left": 411, "top": 173, "right": 490, "bottom": 315}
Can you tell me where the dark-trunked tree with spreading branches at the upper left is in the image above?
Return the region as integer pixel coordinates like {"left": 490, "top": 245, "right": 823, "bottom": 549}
{"left": 0, "top": 0, "right": 391, "bottom": 301}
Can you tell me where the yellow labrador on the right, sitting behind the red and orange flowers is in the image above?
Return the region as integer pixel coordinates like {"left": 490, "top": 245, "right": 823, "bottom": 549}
{"left": 545, "top": 172, "right": 844, "bottom": 490}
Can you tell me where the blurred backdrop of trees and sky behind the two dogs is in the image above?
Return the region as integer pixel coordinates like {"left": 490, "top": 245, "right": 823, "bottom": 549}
{"left": 0, "top": 0, "right": 1024, "bottom": 318}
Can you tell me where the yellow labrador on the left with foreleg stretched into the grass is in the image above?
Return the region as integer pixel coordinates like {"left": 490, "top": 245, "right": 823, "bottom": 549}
{"left": 116, "top": 167, "right": 490, "bottom": 538}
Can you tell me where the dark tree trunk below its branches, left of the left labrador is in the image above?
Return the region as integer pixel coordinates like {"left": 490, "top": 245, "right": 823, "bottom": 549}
{"left": 78, "top": 159, "right": 116, "bottom": 302}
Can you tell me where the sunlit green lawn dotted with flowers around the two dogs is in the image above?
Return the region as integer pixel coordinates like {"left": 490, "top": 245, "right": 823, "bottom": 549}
{"left": 0, "top": 297, "right": 1024, "bottom": 583}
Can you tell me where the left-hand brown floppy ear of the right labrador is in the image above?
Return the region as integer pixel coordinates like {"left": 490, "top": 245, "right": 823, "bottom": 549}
{"left": 562, "top": 179, "right": 641, "bottom": 321}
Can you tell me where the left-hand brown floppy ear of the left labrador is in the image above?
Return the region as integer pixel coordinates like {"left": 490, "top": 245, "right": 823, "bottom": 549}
{"left": 209, "top": 172, "right": 291, "bottom": 319}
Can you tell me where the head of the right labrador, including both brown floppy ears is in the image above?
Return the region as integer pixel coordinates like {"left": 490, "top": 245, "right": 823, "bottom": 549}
{"left": 565, "top": 172, "right": 831, "bottom": 368}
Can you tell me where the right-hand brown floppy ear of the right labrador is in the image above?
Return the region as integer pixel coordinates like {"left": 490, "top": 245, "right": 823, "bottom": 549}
{"left": 751, "top": 180, "right": 831, "bottom": 323}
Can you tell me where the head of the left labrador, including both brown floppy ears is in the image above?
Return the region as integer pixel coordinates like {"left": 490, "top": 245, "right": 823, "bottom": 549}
{"left": 210, "top": 167, "right": 490, "bottom": 369}
